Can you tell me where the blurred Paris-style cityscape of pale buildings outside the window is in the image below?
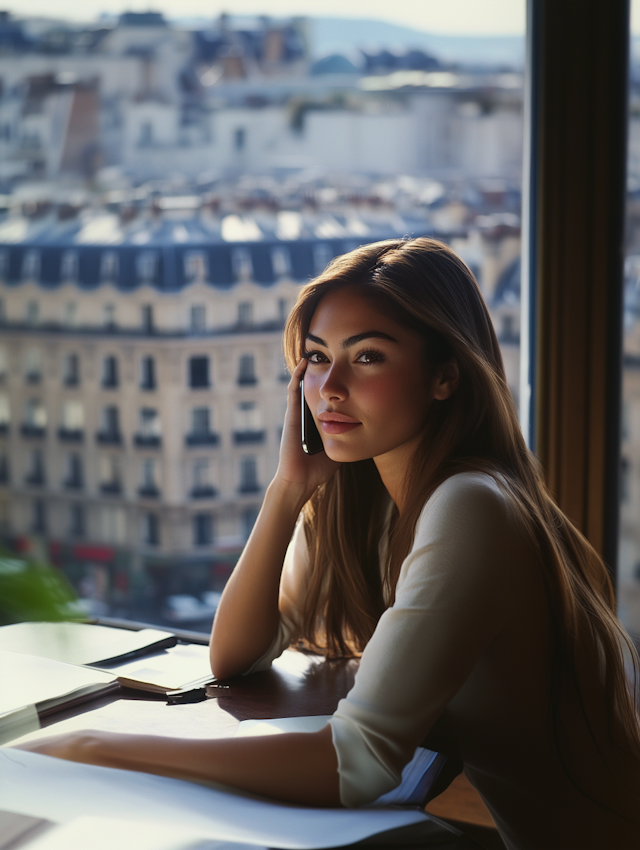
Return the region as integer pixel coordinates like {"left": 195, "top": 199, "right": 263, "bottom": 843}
{"left": 0, "top": 12, "right": 640, "bottom": 629}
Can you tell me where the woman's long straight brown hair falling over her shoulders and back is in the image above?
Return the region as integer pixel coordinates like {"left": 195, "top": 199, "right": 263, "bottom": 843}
{"left": 284, "top": 238, "right": 640, "bottom": 780}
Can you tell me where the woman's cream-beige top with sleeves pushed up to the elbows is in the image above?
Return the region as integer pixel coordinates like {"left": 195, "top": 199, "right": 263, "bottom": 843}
{"left": 246, "top": 473, "right": 640, "bottom": 850}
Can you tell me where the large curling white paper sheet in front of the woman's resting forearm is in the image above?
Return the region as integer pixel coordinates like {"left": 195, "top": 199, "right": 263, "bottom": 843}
{"left": 0, "top": 747, "right": 429, "bottom": 850}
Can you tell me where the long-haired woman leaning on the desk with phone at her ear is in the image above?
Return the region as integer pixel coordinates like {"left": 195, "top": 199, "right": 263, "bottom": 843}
{"left": 17, "top": 239, "right": 640, "bottom": 850}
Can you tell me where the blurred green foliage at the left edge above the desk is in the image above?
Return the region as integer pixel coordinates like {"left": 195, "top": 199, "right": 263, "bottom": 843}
{"left": 0, "top": 553, "right": 81, "bottom": 625}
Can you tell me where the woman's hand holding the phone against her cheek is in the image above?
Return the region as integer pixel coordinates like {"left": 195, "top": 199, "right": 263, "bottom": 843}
{"left": 273, "top": 359, "right": 340, "bottom": 503}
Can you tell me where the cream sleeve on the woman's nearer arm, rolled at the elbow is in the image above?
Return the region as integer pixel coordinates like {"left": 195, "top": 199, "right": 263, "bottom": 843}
{"left": 330, "top": 473, "right": 519, "bottom": 806}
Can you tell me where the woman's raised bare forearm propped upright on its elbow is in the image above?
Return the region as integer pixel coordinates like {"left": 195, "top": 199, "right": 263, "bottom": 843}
{"left": 210, "top": 482, "right": 306, "bottom": 679}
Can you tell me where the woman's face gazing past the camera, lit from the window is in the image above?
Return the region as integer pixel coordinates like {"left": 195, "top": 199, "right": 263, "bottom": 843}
{"left": 304, "top": 288, "right": 449, "bottom": 472}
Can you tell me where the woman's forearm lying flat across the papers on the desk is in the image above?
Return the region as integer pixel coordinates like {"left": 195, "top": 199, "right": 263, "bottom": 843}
{"left": 24, "top": 726, "right": 340, "bottom": 807}
